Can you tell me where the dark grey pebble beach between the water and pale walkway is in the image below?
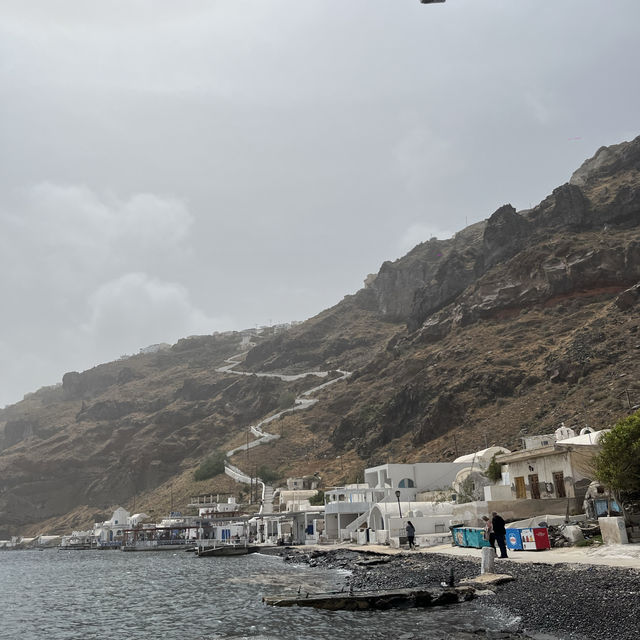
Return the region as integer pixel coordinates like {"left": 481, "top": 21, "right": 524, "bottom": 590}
{"left": 281, "top": 549, "right": 640, "bottom": 640}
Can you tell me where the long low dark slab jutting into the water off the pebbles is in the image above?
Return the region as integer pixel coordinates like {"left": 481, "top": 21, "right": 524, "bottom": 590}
{"left": 262, "top": 586, "right": 475, "bottom": 611}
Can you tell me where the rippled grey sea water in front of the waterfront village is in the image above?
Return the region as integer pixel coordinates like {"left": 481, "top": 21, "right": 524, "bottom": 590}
{"left": 0, "top": 550, "right": 520, "bottom": 640}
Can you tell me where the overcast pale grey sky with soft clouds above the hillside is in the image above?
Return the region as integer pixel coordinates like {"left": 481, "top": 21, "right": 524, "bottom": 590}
{"left": 0, "top": 0, "right": 640, "bottom": 406}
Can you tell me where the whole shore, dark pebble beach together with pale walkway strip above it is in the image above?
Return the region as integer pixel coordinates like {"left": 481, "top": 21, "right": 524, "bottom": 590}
{"left": 278, "top": 545, "right": 640, "bottom": 640}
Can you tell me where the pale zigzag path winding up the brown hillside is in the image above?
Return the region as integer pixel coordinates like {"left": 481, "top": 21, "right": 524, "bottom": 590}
{"left": 216, "top": 353, "right": 351, "bottom": 514}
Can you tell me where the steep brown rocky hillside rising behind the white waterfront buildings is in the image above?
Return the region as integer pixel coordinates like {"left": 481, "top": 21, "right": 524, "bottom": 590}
{"left": 0, "top": 138, "right": 640, "bottom": 534}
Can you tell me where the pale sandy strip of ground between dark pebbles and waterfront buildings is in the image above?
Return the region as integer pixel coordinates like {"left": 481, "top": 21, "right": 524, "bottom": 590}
{"left": 304, "top": 544, "right": 640, "bottom": 570}
